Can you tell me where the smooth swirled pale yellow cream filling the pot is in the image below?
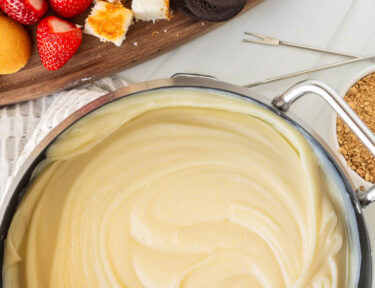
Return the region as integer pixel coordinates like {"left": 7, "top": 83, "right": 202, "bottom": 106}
{"left": 3, "top": 89, "right": 350, "bottom": 288}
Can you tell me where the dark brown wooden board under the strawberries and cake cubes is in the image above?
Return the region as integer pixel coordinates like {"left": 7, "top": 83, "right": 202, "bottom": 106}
{"left": 0, "top": 0, "right": 263, "bottom": 106}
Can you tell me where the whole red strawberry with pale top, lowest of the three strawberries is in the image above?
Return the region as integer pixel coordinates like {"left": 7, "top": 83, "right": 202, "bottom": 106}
{"left": 36, "top": 16, "right": 82, "bottom": 70}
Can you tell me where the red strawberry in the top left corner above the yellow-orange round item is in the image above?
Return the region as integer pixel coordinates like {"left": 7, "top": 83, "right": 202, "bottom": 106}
{"left": 0, "top": 0, "right": 48, "bottom": 25}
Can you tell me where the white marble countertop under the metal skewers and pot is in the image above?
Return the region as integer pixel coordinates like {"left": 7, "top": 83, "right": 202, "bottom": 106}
{"left": 120, "top": 0, "right": 375, "bottom": 280}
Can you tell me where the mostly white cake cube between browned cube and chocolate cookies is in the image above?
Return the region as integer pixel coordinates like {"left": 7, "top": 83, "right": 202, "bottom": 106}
{"left": 132, "top": 0, "right": 171, "bottom": 22}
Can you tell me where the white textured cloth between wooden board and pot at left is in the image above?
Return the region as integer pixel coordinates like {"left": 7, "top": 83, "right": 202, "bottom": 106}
{"left": 0, "top": 77, "right": 127, "bottom": 198}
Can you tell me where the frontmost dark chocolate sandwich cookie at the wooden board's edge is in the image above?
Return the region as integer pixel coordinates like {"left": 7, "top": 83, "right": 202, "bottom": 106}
{"left": 185, "top": 0, "right": 246, "bottom": 22}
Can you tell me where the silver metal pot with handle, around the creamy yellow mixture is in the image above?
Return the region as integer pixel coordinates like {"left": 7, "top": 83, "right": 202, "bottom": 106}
{"left": 0, "top": 74, "right": 375, "bottom": 288}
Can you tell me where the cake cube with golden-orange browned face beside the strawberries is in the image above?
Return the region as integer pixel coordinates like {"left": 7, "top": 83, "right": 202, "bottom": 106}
{"left": 84, "top": 1, "right": 133, "bottom": 46}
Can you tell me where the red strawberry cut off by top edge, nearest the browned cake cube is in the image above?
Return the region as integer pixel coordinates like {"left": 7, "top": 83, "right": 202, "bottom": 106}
{"left": 49, "top": 0, "right": 92, "bottom": 18}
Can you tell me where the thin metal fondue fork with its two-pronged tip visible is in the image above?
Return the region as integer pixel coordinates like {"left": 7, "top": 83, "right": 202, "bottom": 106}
{"left": 242, "top": 32, "right": 361, "bottom": 58}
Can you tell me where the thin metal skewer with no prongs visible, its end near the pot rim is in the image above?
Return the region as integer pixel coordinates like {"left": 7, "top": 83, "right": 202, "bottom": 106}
{"left": 244, "top": 55, "right": 375, "bottom": 88}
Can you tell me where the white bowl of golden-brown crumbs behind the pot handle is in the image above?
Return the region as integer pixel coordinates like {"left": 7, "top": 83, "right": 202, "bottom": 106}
{"left": 331, "top": 66, "right": 375, "bottom": 189}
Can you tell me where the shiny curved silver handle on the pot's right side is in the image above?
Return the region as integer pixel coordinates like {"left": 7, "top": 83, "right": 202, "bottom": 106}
{"left": 272, "top": 80, "right": 375, "bottom": 207}
